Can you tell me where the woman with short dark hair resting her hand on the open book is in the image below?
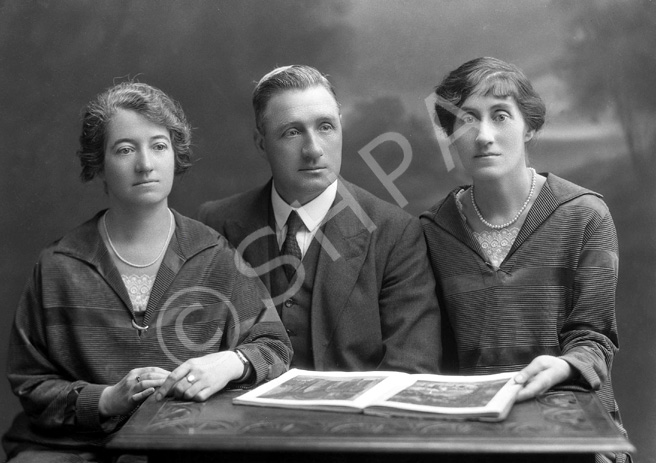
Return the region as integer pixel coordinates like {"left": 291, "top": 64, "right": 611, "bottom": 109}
{"left": 421, "top": 58, "right": 625, "bottom": 461}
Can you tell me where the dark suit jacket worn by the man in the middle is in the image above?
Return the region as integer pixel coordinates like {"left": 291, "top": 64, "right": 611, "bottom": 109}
{"left": 199, "top": 179, "right": 441, "bottom": 373}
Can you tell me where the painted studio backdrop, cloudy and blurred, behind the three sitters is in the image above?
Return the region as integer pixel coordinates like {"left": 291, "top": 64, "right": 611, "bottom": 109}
{"left": 0, "top": 0, "right": 656, "bottom": 462}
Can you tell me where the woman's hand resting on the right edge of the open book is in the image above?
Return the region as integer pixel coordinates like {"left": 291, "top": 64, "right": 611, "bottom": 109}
{"left": 514, "top": 355, "right": 574, "bottom": 402}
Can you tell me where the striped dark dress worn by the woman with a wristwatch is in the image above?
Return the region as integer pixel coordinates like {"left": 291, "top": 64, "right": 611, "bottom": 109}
{"left": 3, "top": 213, "right": 292, "bottom": 456}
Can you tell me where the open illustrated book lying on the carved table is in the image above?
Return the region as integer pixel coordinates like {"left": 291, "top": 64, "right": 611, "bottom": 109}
{"left": 233, "top": 369, "right": 522, "bottom": 421}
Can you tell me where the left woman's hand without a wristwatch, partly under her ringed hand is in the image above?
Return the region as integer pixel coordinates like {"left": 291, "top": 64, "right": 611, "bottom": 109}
{"left": 98, "top": 367, "right": 169, "bottom": 418}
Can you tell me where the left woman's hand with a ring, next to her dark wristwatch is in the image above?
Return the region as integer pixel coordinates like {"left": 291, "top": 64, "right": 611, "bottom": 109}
{"left": 157, "top": 351, "right": 244, "bottom": 402}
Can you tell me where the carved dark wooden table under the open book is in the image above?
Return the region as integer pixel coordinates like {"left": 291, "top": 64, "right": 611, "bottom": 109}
{"left": 108, "top": 391, "right": 635, "bottom": 463}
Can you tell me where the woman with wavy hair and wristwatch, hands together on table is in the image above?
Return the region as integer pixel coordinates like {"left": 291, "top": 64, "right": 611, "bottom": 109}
{"left": 3, "top": 82, "right": 291, "bottom": 462}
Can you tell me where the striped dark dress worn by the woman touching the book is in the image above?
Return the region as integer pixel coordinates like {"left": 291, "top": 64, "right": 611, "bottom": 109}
{"left": 421, "top": 174, "right": 621, "bottom": 463}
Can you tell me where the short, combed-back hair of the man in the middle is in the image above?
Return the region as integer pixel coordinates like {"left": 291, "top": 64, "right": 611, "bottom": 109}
{"left": 253, "top": 64, "right": 339, "bottom": 135}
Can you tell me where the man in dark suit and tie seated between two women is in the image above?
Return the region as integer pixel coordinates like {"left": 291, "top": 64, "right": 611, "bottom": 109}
{"left": 199, "top": 66, "right": 441, "bottom": 373}
